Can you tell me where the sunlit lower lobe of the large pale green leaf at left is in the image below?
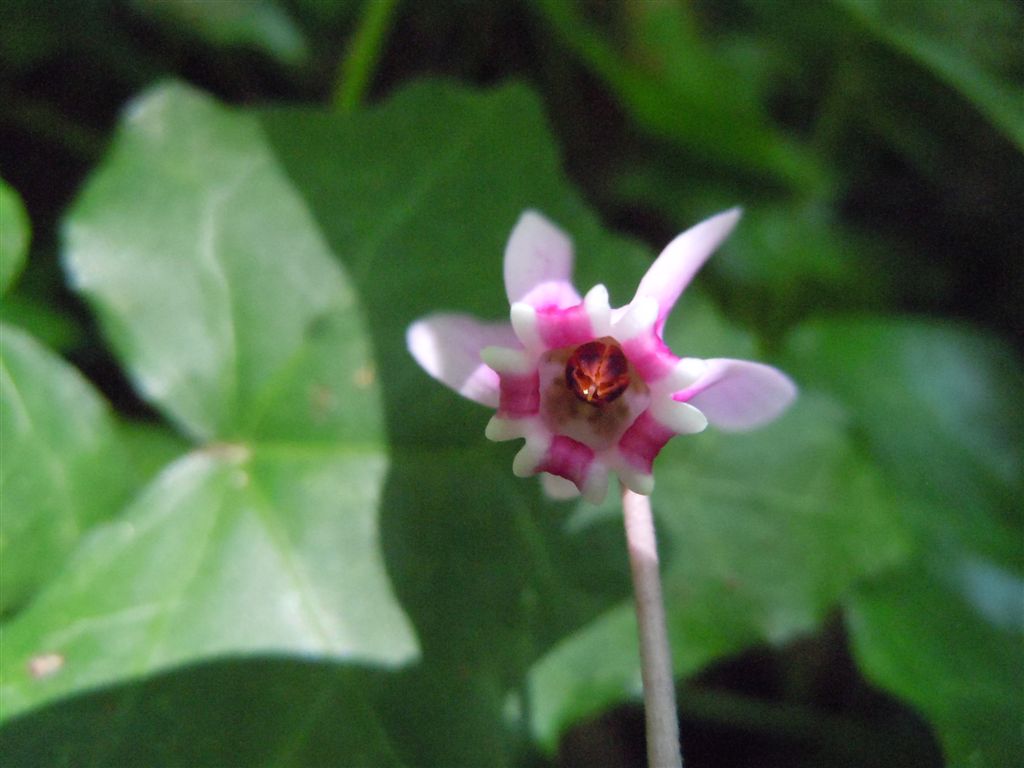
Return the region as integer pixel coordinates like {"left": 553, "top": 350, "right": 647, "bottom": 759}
{"left": 0, "top": 444, "right": 415, "bottom": 717}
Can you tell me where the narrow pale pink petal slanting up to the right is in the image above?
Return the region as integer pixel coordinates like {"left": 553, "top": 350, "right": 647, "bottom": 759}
{"left": 633, "top": 208, "right": 741, "bottom": 332}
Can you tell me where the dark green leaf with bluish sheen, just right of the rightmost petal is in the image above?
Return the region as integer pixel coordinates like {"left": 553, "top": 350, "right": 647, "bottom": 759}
{"left": 784, "top": 318, "right": 1024, "bottom": 568}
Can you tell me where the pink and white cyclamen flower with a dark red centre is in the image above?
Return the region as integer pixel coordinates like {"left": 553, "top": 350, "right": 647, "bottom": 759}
{"left": 407, "top": 209, "right": 797, "bottom": 503}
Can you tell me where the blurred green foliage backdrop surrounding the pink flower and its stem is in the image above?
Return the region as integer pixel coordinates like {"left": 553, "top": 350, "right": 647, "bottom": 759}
{"left": 0, "top": 0, "right": 1024, "bottom": 768}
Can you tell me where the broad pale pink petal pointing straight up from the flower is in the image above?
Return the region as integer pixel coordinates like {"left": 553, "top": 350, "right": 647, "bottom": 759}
{"left": 505, "top": 211, "right": 580, "bottom": 308}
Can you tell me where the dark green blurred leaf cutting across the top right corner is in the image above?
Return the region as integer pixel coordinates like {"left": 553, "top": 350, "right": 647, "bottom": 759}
{"left": 835, "top": 0, "right": 1024, "bottom": 151}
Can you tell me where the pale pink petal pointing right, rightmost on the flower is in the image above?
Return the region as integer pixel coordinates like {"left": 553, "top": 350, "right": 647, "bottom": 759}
{"left": 675, "top": 357, "right": 797, "bottom": 430}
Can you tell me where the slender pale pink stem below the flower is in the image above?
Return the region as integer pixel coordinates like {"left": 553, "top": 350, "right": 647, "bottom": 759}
{"left": 623, "top": 487, "right": 683, "bottom": 768}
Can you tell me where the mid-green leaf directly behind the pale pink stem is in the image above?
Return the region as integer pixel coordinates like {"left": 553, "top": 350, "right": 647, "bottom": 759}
{"left": 529, "top": 395, "right": 908, "bottom": 750}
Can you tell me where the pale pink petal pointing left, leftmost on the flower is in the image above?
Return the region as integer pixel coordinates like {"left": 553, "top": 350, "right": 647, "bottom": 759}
{"left": 406, "top": 314, "right": 519, "bottom": 408}
